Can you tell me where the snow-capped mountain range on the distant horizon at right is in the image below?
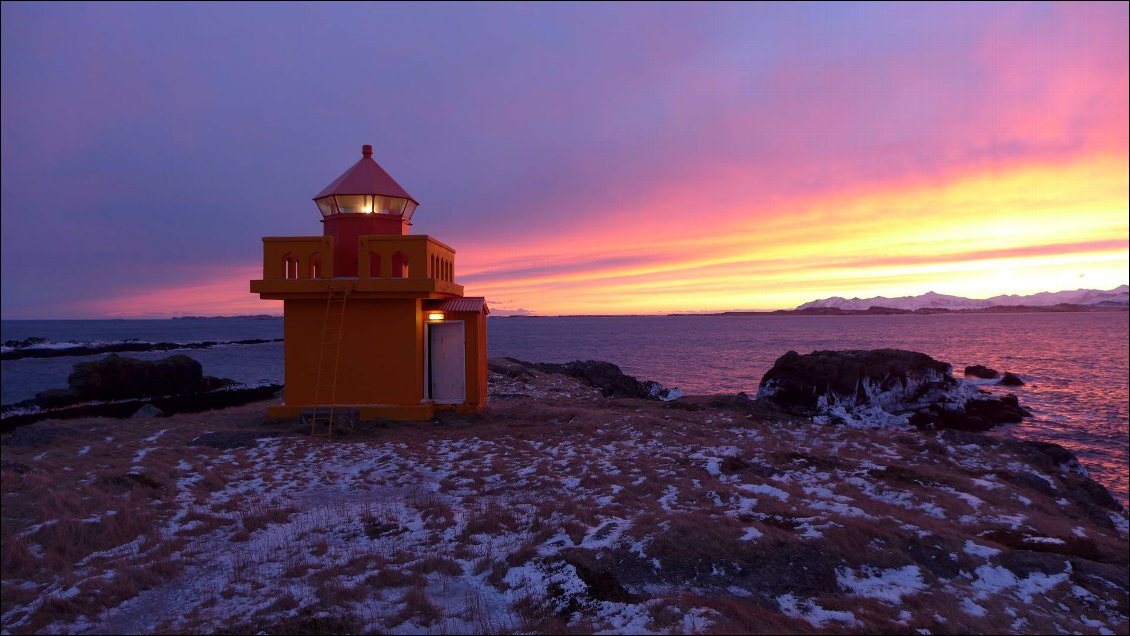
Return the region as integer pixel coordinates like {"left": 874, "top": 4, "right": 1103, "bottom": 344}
{"left": 797, "top": 285, "right": 1130, "bottom": 311}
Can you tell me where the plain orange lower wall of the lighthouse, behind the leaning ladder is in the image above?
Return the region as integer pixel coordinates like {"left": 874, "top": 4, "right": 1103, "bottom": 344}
{"left": 283, "top": 298, "right": 424, "bottom": 406}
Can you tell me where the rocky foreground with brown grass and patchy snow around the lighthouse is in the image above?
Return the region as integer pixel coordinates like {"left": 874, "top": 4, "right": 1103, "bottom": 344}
{"left": 0, "top": 360, "right": 1130, "bottom": 634}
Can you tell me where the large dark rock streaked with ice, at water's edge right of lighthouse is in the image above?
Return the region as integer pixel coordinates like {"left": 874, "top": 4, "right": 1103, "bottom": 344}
{"left": 757, "top": 349, "right": 1031, "bottom": 432}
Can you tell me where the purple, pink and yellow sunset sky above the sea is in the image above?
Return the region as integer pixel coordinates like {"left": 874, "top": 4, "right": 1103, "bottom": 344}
{"left": 0, "top": 2, "right": 1130, "bottom": 320}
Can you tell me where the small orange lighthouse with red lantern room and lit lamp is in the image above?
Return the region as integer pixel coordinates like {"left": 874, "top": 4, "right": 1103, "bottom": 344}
{"left": 251, "top": 146, "right": 488, "bottom": 428}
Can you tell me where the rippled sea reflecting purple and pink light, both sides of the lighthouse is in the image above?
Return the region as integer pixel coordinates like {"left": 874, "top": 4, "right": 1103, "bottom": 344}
{"left": 0, "top": 312, "right": 1130, "bottom": 505}
